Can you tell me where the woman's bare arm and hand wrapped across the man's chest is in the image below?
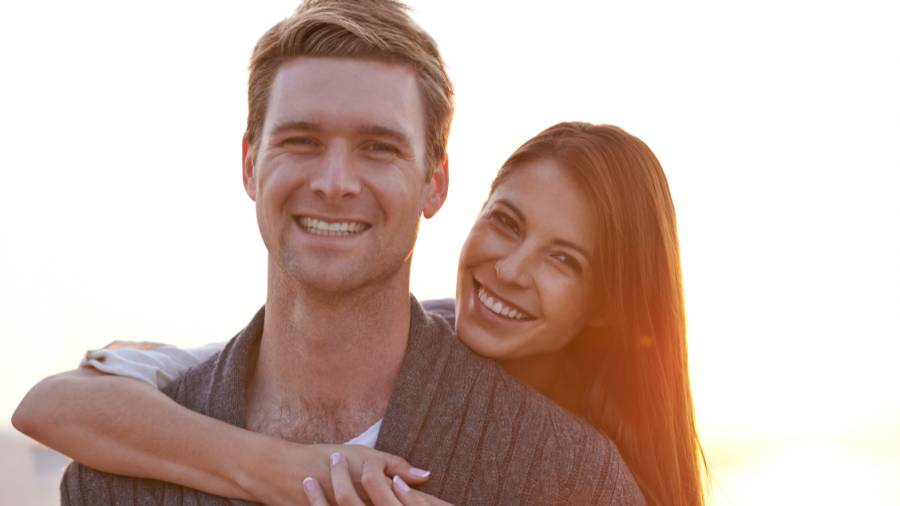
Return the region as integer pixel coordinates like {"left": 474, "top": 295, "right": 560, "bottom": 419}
{"left": 13, "top": 368, "right": 427, "bottom": 504}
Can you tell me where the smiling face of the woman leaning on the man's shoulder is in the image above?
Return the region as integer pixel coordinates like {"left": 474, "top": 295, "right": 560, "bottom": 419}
{"left": 456, "top": 159, "right": 598, "bottom": 361}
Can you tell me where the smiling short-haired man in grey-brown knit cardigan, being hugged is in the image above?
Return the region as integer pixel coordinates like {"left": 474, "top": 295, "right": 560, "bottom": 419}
{"left": 17, "top": 0, "right": 643, "bottom": 504}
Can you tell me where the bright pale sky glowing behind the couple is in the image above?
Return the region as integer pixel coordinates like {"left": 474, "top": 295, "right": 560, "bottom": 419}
{"left": 0, "top": 0, "right": 900, "bottom": 505}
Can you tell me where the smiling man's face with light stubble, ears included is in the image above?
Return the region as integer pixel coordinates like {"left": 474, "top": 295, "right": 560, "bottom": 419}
{"left": 244, "top": 57, "right": 447, "bottom": 293}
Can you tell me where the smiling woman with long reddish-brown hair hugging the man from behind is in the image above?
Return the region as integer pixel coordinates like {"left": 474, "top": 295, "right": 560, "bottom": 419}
{"left": 16, "top": 123, "right": 703, "bottom": 505}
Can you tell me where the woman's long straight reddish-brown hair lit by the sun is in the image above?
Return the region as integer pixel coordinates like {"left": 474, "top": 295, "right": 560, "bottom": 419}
{"left": 491, "top": 123, "right": 706, "bottom": 506}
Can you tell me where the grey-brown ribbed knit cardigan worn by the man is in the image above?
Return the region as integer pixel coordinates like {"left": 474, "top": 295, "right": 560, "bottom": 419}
{"left": 60, "top": 299, "right": 645, "bottom": 506}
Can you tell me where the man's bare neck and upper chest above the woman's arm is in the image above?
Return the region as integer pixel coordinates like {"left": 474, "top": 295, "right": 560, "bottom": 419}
{"left": 248, "top": 260, "right": 410, "bottom": 442}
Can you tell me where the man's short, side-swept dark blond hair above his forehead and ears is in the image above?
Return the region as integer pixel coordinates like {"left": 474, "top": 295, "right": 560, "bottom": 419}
{"left": 245, "top": 0, "right": 453, "bottom": 172}
